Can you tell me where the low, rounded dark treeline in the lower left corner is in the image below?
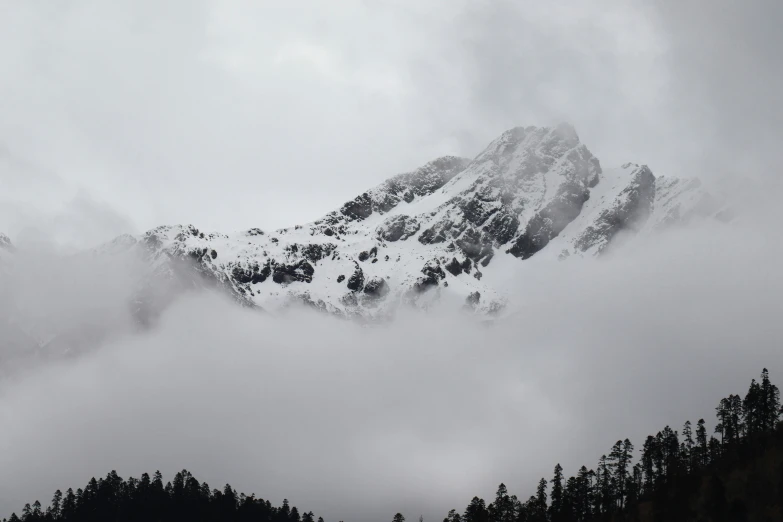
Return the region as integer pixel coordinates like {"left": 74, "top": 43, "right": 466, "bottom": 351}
{"left": 3, "top": 470, "right": 323, "bottom": 522}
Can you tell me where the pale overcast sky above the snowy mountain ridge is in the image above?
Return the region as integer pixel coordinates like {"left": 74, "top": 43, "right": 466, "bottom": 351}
{"left": 0, "top": 0, "right": 783, "bottom": 246}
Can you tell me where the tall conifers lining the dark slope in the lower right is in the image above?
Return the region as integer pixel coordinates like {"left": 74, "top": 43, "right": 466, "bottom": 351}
{"left": 434, "top": 368, "right": 782, "bottom": 522}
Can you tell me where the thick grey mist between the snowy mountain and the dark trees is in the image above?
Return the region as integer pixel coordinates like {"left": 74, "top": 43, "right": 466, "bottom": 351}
{"left": 0, "top": 208, "right": 783, "bottom": 522}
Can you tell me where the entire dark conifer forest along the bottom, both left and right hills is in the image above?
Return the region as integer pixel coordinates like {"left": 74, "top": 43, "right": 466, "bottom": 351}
{"left": 3, "top": 369, "right": 783, "bottom": 522}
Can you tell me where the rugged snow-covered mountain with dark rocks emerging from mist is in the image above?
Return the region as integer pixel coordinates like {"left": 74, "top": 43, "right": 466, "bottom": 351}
{"left": 0, "top": 124, "right": 720, "bottom": 318}
